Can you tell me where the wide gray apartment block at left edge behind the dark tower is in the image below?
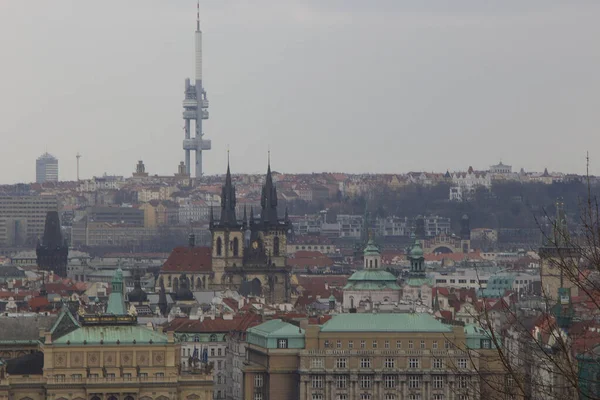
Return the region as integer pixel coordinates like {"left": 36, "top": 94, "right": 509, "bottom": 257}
{"left": 0, "top": 195, "right": 58, "bottom": 246}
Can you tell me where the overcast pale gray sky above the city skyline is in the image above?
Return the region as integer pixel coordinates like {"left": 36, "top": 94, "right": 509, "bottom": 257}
{"left": 0, "top": 0, "right": 600, "bottom": 183}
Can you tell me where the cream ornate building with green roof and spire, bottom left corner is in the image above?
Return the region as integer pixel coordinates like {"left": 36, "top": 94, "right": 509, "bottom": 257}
{"left": 0, "top": 270, "right": 212, "bottom": 400}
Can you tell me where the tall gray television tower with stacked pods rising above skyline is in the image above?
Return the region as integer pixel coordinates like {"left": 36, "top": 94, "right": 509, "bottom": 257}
{"left": 183, "top": 0, "right": 211, "bottom": 179}
